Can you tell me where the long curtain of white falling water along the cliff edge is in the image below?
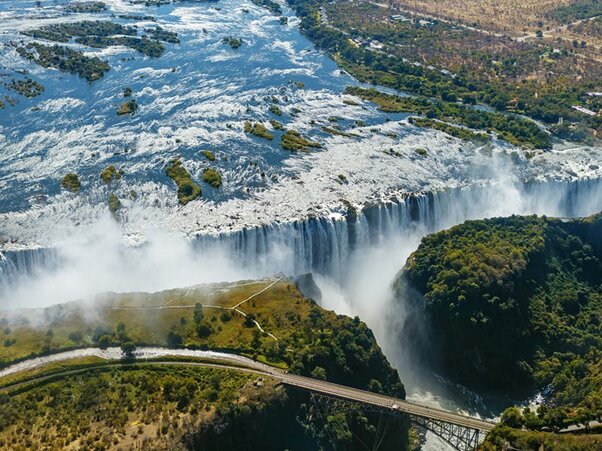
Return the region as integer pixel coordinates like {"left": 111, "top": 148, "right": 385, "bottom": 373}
{"left": 0, "top": 179, "right": 602, "bottom": 300}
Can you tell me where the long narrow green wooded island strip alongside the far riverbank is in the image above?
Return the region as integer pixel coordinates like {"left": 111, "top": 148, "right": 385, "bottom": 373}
{"left": 345, "top": 86, "right": 552, "bottom": 149}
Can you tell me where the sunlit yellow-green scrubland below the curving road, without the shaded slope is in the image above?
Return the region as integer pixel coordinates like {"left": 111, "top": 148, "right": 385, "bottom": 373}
{"left": 0, "top": 365, "right": 264, "bottom": 450}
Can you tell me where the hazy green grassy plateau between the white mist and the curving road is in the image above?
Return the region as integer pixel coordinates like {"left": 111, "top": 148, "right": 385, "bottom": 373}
{"left": 0, "top": 282, "right": 302, "bottom": 370}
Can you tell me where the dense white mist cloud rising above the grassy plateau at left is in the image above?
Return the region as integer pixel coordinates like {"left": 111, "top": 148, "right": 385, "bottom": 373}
{"left": 0, "top": 217, "right": 257, "bottom": 308}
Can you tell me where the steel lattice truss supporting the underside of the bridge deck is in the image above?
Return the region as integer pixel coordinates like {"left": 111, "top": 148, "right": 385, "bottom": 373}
{"left": 310, "top": 393, "right": 486, "bottom": 451}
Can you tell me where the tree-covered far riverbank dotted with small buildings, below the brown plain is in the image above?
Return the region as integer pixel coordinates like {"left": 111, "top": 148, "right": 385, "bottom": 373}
{"left": 288, "top": 0, "right": 602, "bottom": 148}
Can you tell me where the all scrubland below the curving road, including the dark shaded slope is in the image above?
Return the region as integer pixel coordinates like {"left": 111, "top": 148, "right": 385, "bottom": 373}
{"left": 0, "top": 362, "right": 407, "bottom": 451}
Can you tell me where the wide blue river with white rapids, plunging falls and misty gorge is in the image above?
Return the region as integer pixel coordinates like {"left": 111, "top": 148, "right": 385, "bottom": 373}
{"left": 0, "top": 0, "right": 602, "bottom": 448}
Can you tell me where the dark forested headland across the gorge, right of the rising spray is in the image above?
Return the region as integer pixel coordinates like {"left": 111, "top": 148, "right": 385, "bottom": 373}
{"left": 397, "top": 215, "right": 602, "bottom": 429}
